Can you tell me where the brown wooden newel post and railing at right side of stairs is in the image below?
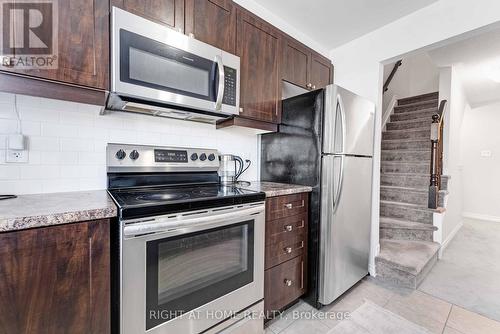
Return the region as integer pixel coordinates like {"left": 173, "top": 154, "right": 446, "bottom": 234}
{"left": 428, "top": 100, "right": 447, "bottom": 209}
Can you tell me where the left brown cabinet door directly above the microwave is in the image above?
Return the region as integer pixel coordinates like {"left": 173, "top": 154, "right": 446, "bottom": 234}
{"left": 111, "top": 0, "right": 184, "bottom": 32}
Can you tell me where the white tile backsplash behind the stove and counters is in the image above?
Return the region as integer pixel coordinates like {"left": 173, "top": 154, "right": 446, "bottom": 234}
{"left": 0, "top": 93, "right": 259, "bottom": 194}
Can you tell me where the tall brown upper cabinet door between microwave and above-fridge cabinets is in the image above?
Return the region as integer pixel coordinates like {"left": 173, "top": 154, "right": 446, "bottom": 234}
{"left": 236, "top": 10, "right": 281, "bottom": 123}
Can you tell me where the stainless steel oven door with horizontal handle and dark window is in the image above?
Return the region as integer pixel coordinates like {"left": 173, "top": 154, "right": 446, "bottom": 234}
{"left": 121, "top": 204, "right": 265, "bottom": 334}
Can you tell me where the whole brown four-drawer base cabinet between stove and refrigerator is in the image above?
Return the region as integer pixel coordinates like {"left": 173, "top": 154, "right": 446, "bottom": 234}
{"left": 264, "top": 193, "right": 309, "bottom": 315}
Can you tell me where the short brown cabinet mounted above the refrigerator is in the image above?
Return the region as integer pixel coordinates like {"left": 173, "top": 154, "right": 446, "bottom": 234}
{"left": 281, "top": 37, "right": 333, "bottom": 90}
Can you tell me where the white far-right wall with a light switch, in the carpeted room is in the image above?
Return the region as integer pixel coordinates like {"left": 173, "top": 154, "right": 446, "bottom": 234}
{"left": 462, "top": 103, "right": 500, "bottom": 220}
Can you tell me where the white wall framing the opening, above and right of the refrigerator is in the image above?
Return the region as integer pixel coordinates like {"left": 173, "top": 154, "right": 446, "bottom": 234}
{"left": 330, "top": 0, "right": 500, "bottom": 274}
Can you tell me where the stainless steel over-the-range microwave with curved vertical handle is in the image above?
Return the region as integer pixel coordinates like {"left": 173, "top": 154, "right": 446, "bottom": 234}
{"left": 106, "top": 7, "right": 240, "bottom": 123}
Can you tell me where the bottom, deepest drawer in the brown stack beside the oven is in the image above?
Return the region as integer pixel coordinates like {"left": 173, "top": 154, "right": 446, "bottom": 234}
{"left": 264, "top": 256, "right": 307, "bottom": 311}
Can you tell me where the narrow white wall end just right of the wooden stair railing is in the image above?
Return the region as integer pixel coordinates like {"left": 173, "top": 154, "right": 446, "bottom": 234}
{"left": 439, "top": 67, "right": 470, "bottom": 242}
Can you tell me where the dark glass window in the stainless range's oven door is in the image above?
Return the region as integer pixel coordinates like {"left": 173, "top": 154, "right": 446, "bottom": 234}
{"left": 146, "top": 220, "right": 254, "bottom": 330}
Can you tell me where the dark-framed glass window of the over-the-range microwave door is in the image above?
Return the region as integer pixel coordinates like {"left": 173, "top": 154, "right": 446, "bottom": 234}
{"left": 120, "top": 29, "right": 219, "bottom": 101}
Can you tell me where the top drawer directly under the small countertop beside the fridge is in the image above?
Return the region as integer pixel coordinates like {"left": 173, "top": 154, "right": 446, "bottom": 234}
{"left": 266, "top": 193, "right": 308, "bottom": 221}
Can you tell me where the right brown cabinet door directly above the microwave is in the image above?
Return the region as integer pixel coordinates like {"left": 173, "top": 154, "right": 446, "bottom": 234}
{"left": 185, "top": 0, "right": 236, "bottom": 54}
